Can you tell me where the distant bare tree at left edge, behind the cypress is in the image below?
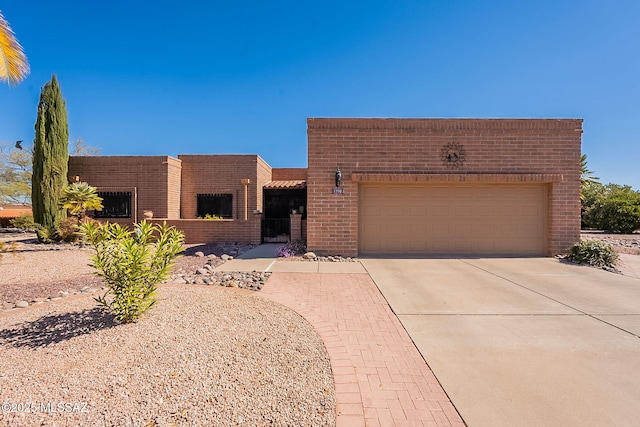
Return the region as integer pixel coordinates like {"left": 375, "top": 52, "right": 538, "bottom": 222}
{"left": 0, "top": 142, "right": 32, "bottom": 204}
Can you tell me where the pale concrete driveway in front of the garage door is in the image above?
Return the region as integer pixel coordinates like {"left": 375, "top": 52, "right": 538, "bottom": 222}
{"left": 361, "top": 258, "right": 640, "bottom": 427}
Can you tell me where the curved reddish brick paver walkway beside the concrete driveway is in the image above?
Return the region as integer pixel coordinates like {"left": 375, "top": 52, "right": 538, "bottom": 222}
{"left": 259, "top": 273, "right": 464, "bottom": 427}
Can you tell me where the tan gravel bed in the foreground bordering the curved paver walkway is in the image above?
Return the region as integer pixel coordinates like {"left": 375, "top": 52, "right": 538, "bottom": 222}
{"left": 0, "top": 285, "right": 335, "bottom": 426}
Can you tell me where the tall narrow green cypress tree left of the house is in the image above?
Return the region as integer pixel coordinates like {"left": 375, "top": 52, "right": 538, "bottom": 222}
{"left": 31, "top": 74, "right": 69, "bottom": 240}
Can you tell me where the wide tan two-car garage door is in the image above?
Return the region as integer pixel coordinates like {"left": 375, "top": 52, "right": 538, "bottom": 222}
{"left": 358, "top": 183, "right": 547, "bottom": 255}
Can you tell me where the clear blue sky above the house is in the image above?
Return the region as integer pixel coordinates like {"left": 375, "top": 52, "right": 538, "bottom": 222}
{"left": 0, "top": 0, "right": 640, "bottom": 190}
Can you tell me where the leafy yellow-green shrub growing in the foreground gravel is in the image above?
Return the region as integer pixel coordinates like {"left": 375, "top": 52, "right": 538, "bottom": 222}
{"left": 80, "top": 221, "right": 184, "bottom": 323}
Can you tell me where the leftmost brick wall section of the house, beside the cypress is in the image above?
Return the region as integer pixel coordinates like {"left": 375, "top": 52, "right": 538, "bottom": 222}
{"left": 69, "top": 156, "right": 180, "bottom": 223}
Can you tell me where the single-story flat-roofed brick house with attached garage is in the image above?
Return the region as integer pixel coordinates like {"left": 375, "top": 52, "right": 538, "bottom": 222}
{"left": 69, "top": 118, "right": 582, "bottom": 256}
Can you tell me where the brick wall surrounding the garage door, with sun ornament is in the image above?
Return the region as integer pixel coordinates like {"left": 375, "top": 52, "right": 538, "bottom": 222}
{"left": 307, "top": 118, "right": 582, "bottom": 256}
